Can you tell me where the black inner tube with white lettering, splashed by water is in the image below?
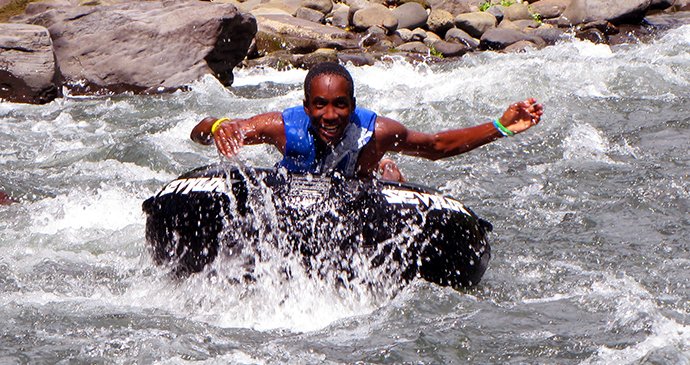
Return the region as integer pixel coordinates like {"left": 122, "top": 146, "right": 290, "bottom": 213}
{"left": 143, "top": 165, "right": 492, "bottom": 287}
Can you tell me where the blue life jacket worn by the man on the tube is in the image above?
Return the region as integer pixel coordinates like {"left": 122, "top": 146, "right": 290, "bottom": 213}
{"left": 278, "top": 106, "right": 376, "bottom": 177}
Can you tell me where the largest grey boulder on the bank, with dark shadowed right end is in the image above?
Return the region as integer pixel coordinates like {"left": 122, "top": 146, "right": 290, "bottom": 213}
{"left": 12, "top": 0, "right": 256, "bottom": 95}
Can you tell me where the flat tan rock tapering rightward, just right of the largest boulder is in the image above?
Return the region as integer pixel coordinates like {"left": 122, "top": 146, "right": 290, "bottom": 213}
{"left": 256, "top": 15, "right": 359, "bottom": 56}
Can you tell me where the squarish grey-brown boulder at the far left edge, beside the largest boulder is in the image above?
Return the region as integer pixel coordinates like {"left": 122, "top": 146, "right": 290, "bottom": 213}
{"left": 0, "top": 24, "right": 60, "bottom": 103}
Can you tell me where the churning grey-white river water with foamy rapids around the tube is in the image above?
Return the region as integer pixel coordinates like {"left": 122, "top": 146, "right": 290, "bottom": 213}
{"left": 0, "top": 26, "right": 690, "bottom": 364}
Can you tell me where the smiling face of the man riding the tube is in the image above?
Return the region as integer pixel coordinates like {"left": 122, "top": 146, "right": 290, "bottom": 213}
{"left": 304, "top": 75, "right": 354, "bottom": 145}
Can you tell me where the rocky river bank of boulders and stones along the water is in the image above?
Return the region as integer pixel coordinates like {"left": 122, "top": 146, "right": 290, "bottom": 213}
{"left": 0, "top": 0, "right": 690, "bottom": 104}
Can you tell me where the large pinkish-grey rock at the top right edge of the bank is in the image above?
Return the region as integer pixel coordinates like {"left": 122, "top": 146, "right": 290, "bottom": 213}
{"left": 561, "top": 0, "right": 651, "bottom": 26}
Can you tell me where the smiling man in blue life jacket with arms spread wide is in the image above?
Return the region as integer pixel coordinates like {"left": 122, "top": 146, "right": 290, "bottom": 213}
{"left": 191, "top": 62, "right": 543, "bottom": 181}
